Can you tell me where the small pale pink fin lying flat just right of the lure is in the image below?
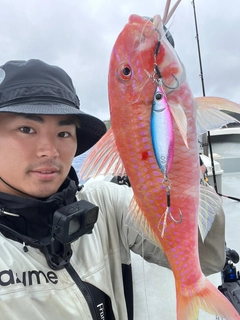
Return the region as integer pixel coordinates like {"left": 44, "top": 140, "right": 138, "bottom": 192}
{"left": 169, "top": 102, "right": 188, "bottom": 148}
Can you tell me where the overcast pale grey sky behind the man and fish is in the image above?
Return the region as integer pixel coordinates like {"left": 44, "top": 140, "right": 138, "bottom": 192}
{"left": 0, "top": 0, "right": 240, "bottom": 120}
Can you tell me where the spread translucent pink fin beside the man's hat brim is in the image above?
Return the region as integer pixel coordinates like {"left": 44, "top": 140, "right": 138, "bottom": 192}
{"left": 79, "top": 128, "right": 125, "bottom": 180}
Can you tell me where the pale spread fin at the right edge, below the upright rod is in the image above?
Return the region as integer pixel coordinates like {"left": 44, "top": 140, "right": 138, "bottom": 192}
{"left": 195, "top": 97, "right": 240, "bottom": 135}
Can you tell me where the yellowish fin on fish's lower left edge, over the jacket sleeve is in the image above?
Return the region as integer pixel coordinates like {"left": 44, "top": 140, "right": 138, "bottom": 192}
{"left": 126, "top": 196, "right": 161, "bottom": 247}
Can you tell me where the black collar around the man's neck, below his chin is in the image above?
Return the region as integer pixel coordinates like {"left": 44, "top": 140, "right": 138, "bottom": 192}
{"left": 0, "top": 177, "right": 78, "bottom": 240}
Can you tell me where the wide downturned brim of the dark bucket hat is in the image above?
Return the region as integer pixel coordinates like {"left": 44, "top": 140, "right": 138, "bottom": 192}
{"left": 0, "top": 102, "right": 107, "bottom": 157}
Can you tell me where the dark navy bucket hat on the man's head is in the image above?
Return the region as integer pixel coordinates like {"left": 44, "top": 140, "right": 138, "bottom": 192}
{"left": 0, "top": 59, "right": 106, "bottom": 156}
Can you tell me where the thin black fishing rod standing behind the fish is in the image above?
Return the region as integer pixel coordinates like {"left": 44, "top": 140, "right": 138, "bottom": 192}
{"left": 192, "top": 0, "right": 240, "bottom": 201}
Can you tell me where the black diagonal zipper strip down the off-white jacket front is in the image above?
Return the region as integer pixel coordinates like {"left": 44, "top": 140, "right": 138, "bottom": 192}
{"left": 65, "top": 263, "right": 100, "bottom": 320}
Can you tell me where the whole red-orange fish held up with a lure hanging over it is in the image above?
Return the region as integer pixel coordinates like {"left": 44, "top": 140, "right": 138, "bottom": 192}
{"left": 81, "top": 11, "right": 240, "bottom": 320}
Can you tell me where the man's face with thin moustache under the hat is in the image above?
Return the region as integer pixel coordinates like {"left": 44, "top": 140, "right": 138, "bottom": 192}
{"left": 0, "top": 113, "right": 77, "bottom": 198}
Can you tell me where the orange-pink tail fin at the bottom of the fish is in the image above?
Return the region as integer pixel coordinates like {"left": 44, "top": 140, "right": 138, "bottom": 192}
{"left": 177, "top": 278, "right": 240, "bottom": 320}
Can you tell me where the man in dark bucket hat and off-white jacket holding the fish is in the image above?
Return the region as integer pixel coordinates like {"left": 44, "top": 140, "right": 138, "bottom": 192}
{"left": 0, "top": 60, "right": 225, "bottom": 320}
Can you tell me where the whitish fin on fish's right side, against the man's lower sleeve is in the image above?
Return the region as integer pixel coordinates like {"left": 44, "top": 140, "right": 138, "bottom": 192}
{"left": 198, "top": 185, "right": 222, "bottom": 242}
